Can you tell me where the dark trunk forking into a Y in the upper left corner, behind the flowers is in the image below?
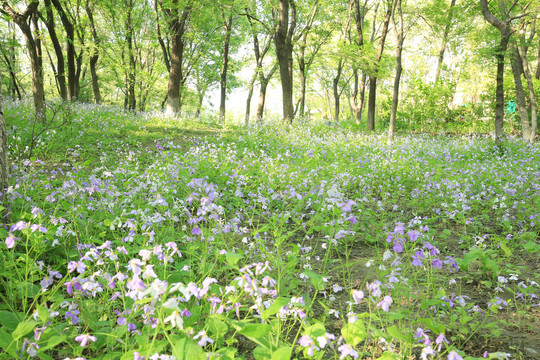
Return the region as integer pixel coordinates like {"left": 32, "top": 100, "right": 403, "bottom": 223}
{"left": 2, "top": 1, "right": 46, "bottom": 122}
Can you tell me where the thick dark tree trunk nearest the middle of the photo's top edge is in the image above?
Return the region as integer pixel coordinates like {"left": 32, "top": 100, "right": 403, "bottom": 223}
{"left": 274, "top": 0, "right": 296, "bottom": 123}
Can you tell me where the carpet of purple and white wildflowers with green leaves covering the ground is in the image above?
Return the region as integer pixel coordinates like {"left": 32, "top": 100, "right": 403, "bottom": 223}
{"left": 0, "top": 102, "right": 540, "bottom": 360}
